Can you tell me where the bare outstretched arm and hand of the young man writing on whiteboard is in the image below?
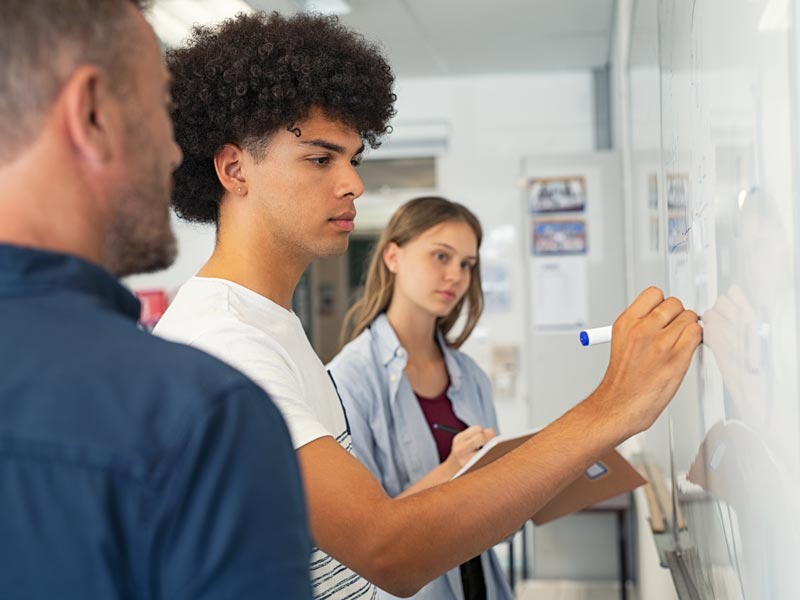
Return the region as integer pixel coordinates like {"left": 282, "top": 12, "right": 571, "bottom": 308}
{"left": 297, "top": 288, "right": 701, "bottom": 595}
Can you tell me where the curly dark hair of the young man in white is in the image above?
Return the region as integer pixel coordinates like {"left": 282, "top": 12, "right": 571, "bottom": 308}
{"left": 167, "top": 12, "right": 396, "bottom": 223}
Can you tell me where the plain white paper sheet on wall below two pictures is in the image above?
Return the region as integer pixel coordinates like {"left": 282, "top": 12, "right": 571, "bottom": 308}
{"left": 530, "top": 256, "right": 589, "bottom": 330}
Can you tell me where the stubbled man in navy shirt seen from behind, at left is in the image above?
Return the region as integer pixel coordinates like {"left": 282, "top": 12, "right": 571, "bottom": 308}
{"left": 0, "top": 0, "right": 311, "bottom": 600}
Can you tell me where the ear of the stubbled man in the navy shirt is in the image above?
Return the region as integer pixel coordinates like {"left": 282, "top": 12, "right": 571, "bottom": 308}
{"left": 58, "top": 65, "right": 125, "bottom": 165}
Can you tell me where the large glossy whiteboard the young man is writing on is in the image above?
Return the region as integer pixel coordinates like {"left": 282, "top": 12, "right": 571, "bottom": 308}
{"left": 628, "top": 0, "right": 800, "bottom": 600}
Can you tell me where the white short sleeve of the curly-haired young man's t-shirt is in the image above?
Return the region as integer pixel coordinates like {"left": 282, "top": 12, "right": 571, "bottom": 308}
{"left": 192, "top": 322, "right": 335, "bottom": 449}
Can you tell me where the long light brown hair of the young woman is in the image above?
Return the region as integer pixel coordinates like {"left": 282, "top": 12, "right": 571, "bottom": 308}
{"left": 339, "top": 196, "right": 483, "bottom": 348}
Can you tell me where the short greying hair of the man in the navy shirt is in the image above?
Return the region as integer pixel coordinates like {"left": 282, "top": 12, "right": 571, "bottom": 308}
{"left": 0, "top": 0, "right": 148, "bottom": 164}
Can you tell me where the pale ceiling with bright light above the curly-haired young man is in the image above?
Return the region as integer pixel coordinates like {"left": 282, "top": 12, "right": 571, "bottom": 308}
{"left": 148, "top": 0, "right": 615, "bottom": 77}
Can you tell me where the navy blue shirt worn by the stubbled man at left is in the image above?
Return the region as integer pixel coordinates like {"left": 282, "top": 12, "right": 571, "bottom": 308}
{"left": 0, "top": 244, "right": 311, "bottom": 600}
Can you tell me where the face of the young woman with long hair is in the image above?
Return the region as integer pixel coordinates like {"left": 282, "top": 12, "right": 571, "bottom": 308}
{"left": 383, "top": 221, "right": 478, "bottom": 317}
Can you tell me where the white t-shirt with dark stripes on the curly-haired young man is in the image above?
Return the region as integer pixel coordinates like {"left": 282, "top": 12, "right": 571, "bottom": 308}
{"left": 154, "top": 277, "right": 376, "bottom": 600}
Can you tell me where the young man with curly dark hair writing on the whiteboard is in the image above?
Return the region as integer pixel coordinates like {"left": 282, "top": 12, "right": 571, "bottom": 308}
{"left": 157, "top": 9, "right": 700, "bottom": 599}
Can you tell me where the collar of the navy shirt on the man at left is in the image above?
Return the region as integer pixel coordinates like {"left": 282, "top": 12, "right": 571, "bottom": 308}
{"left": 0, "top": 244, "right": 141, "bottom": 321}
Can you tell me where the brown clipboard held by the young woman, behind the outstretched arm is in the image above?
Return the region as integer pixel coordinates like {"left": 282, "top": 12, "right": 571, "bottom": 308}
{"left": 453, "top": 430, "right": 647, "bottom": 525}
